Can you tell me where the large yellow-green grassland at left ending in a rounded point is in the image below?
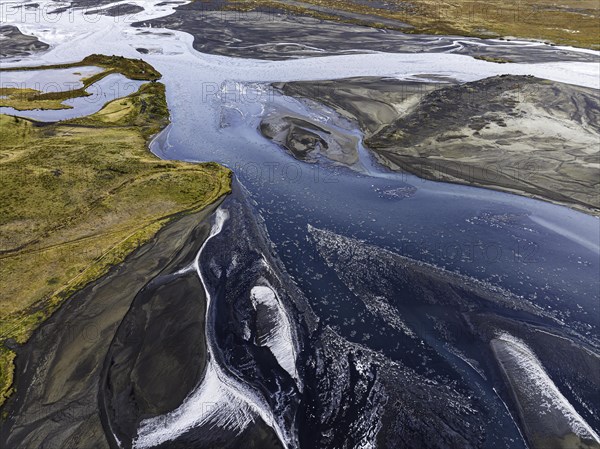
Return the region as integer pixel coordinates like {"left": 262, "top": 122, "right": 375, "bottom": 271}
{"left": 0, "top": 58, "right": 231, "bottom": 404}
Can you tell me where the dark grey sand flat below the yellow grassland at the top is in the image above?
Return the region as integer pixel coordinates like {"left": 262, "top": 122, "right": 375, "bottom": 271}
{"left": 133, "top": 1, "right": 597, "bottom": 62}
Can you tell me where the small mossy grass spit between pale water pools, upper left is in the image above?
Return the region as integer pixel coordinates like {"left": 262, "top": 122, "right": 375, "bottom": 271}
{"left": 0, "top": 55, "right": 161, "bottom": 111}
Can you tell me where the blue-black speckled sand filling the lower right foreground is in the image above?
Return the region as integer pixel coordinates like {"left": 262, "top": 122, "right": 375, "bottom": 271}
{"left": 184, "top": 189, "right": 600, "bottom": 449}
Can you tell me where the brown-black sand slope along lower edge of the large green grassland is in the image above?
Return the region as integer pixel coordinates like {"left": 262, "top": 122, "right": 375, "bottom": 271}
{"left": 0, "top": 204, "right": 223, "bottom": 449}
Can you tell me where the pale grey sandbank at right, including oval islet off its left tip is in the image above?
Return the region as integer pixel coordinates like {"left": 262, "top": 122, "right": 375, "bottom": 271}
{"left": 261, "top": 76, "right": 600, "bottom": 215}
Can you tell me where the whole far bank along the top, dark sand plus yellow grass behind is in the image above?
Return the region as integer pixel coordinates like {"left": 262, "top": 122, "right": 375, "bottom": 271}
{"left": 134, "top": 0, "right": 600, "bottom": 53}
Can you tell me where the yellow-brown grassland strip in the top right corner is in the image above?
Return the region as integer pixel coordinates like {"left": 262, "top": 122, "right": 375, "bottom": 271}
{"left": 260, "top": 0, "right": 600, "bottom": 49}
